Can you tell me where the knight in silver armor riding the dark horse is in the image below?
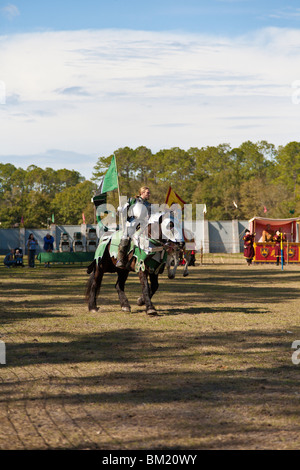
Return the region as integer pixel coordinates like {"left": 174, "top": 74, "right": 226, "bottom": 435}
{"left": 116, "top": 186, "right": 151, "bottom": 268}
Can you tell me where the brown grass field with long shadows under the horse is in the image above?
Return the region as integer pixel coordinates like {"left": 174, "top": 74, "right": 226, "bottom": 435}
{"left": 0, "top": 256, "right": 300, "bottom": 450}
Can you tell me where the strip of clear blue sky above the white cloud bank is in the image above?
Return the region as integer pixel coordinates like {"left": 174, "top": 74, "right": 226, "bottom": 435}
{"left": 1, "top": 0, "right": 300, "bottom": 35}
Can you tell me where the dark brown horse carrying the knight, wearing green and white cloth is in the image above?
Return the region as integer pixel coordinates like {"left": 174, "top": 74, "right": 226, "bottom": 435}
{"left": 86, "top": 213, "right": 184, "bottom": 315}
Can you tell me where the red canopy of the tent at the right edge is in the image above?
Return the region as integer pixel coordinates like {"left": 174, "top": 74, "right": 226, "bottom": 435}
{"left": 249, "top": 217, "right": 300, "bottom": 242}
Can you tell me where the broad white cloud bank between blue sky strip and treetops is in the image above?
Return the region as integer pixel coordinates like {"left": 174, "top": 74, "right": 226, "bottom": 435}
{"left": 0, "top": 28, "right": 300, "bottom": 178}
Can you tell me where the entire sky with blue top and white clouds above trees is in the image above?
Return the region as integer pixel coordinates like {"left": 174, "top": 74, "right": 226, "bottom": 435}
{"left": 0, "top": 0, "right": 300, "bottom": 178}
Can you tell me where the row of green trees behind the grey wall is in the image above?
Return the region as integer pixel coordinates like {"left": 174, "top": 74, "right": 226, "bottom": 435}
{"left": 0, "top": 141, "right": 300, "bottom": 228}
